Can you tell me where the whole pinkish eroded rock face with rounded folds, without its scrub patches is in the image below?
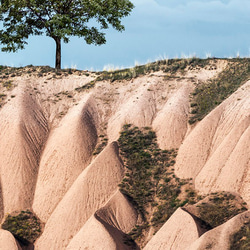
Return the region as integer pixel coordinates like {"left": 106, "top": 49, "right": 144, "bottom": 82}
{"left": 0, "top": 60, "right": 250, "bottom": 250}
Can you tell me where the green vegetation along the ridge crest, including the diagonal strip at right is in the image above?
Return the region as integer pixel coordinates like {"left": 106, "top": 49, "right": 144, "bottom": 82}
{"left": 0, "top": 57, "right": 250, "bottom": 98}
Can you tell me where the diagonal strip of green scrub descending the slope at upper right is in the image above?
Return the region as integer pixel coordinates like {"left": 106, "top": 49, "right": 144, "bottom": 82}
{"left": 189, "top": 58, "right": 250, "bottom": 124}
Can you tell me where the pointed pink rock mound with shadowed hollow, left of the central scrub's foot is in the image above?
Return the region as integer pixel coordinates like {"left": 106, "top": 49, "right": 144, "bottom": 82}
{"left": 67, "top": 191, "right": 138, "bottom": 250}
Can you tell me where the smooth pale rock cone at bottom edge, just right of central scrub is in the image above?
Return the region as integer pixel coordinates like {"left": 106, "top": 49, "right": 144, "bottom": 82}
{"left": 143, "top": 208, "right": 207, "bottom": 250}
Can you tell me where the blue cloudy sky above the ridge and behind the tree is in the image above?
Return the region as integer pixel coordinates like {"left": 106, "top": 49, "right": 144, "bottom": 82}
{"left": 0, "top": 0, "right": 250, "bottom": 71}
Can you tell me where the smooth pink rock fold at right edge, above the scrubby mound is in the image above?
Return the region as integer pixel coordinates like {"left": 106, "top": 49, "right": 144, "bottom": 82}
{"left": 195, "top": 117, "right": 250, "bottom": 204}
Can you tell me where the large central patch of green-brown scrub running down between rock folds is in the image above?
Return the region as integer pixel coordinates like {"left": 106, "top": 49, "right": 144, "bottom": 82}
{"left": 118, "top": 124, "right": 196, "bottom": 242}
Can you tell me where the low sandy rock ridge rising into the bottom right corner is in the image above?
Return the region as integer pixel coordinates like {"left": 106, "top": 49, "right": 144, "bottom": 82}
{"left": 186, "top": 211, "right": 250, "bottom": 250}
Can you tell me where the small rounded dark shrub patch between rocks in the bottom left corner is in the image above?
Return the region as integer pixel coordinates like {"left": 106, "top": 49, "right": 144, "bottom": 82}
{"left": 2, "top": 210, "right": 42, "bottom": 245}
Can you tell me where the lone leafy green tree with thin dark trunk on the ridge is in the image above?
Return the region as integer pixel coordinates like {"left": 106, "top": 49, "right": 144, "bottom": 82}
{"left": 0, "top": 0, "right": 134, "bottom": 69}
